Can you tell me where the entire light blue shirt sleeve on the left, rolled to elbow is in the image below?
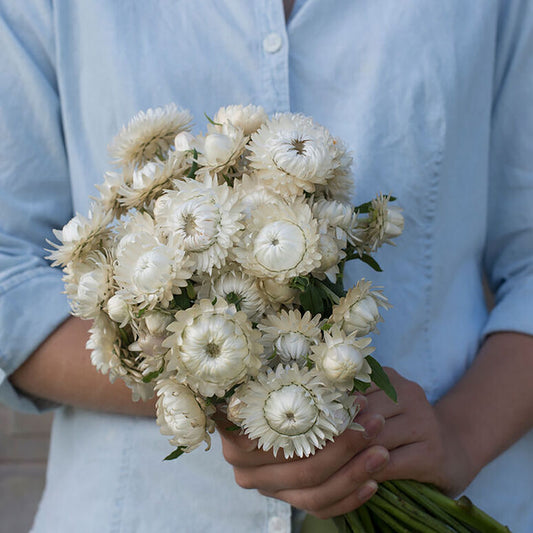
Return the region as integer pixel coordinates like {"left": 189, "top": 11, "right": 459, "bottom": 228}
{"left": 0, "top": 0, "right": 72, "bottom": 412}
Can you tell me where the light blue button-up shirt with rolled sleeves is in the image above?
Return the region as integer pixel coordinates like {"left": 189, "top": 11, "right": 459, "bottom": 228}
{"left": 0, "top": 0, "right": 533, "bottom": 533}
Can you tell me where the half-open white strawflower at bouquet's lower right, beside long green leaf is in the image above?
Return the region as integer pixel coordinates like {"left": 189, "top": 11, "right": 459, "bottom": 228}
{"left": 311, "top": 326, "right": 374, "bottom": 390}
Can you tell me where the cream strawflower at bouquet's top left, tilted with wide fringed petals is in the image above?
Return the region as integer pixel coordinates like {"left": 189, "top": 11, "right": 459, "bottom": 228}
{"left": 109, "top": 104, "right": 192, "bottom": 167}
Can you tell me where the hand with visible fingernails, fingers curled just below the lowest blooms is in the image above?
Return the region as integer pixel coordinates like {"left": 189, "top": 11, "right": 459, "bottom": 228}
{"left": 217, "top": 396, "right": 389, "bottom": 518}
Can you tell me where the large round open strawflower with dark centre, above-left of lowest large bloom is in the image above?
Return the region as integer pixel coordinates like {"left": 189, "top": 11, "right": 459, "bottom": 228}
{"left": 163, "top": 299, "right": 262, "bottom": 397}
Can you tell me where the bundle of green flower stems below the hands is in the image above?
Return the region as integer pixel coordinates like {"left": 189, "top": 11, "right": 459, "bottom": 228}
{"left": 334, "top": 480, "right": 510, "bottom": 533}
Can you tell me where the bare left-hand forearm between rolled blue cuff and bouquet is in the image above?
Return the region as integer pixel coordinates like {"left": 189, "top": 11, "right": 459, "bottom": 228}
{"left": 10, "top": 318, "right": 155, "bottom": 416}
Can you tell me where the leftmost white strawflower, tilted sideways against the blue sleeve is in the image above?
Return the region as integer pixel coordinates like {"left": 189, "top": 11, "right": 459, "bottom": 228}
{"left": 47, "top": 203, "right": 113, "bottom": 267}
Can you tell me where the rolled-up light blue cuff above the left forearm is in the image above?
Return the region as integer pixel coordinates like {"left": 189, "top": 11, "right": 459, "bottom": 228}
{"left": 0, "top": 267, "right": 69, "bottom": 413}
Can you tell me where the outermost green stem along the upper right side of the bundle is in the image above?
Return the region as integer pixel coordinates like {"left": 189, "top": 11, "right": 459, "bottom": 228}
{"left": 404, "top": 480, "right": 510, "bottom": 533}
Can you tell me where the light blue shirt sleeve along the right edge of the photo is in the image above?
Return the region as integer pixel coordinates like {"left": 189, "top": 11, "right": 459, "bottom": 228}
{"left": 484, "top": 0, "right": 533, "bottom": 335}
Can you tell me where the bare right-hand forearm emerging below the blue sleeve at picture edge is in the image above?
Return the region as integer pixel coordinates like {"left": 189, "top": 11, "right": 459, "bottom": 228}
{"left": 435, "top": 332, "right": 533, "bottom": 474}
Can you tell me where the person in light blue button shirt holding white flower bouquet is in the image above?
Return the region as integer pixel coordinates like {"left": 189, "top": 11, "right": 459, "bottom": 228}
{"left": 0, "top": 0, "right": 533, "bottom": 533}
